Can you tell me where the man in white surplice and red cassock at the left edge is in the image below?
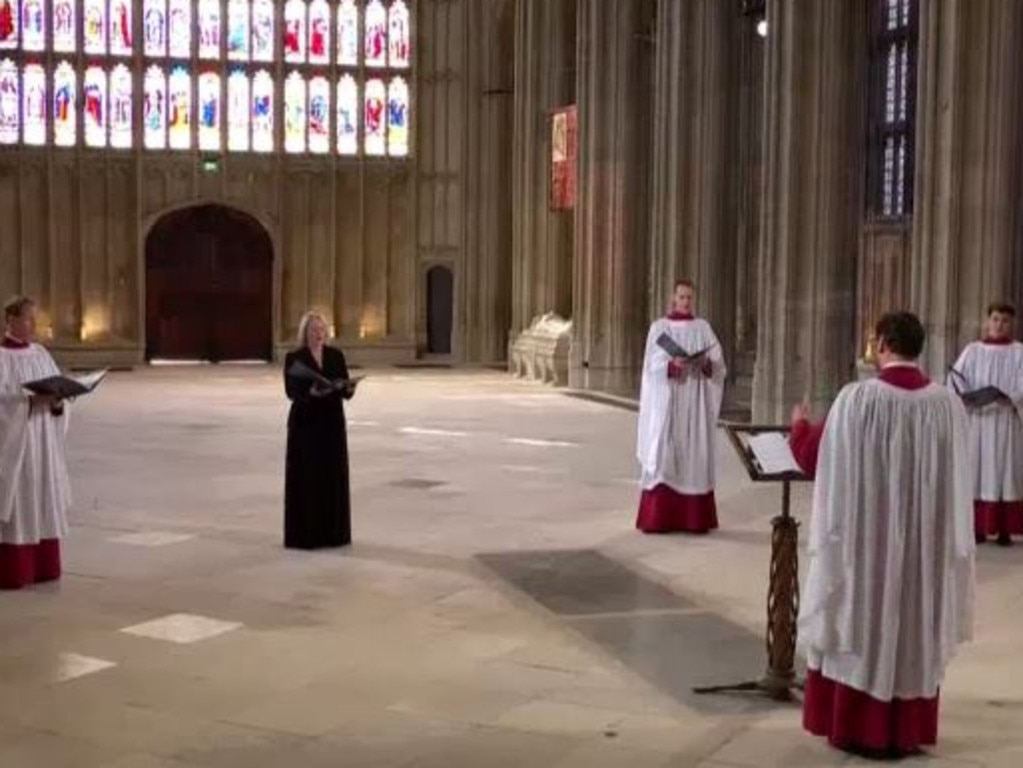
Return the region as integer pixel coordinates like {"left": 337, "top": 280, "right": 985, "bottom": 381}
{"left": 0, "top": 298, "right": 71, "bottom": 589}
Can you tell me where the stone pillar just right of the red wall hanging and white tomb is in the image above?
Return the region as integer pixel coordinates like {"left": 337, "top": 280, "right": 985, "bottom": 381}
{"left": 569, "top": 0, "right": 653, "bottom": 393}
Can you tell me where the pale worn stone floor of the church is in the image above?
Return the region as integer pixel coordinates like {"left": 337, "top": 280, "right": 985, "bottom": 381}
{"left": 0, "top": 367, "right": 1023, "bottom": 768}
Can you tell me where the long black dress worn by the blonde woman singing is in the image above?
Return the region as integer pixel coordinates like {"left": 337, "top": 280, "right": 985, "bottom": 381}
{"left": 284, "top": 347, "right": 352, "bottom": 549}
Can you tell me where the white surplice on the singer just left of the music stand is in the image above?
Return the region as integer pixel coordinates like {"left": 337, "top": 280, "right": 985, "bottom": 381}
{"left": 636, "top": 318, "right": 726, "bottom": 495}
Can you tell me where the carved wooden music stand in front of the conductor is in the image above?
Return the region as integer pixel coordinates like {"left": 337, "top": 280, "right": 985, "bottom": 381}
{"left": 693, "top": 421, "right": 810, "bottom": 702}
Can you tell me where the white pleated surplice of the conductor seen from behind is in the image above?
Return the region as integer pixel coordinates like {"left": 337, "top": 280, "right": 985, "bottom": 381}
{"left": 799, "top": 372, "right": 975, "bottom": 702}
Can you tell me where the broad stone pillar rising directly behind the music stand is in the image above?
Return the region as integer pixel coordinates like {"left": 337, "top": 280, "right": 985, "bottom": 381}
{"left": 753, "top": 0, "right": 866, "bottom": 422}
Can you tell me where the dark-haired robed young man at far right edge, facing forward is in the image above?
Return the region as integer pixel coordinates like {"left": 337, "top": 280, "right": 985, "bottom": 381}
{"left": 948, "top": 304, "right": 1023, "bottom": 546}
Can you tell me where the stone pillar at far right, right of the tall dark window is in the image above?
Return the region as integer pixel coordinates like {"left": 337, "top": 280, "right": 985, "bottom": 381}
{"left": 909, "top": 0, "right": 1023, "bottom": 376}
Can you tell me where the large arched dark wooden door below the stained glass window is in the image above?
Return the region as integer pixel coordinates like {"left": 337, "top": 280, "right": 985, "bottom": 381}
{"left": 145, "top": 206, "right": 273, "bottom": 362}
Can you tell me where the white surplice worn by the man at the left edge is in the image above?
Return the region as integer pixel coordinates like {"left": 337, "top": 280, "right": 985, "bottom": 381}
{"left": 0, "top": 344, "right": 71, "bottom": 544}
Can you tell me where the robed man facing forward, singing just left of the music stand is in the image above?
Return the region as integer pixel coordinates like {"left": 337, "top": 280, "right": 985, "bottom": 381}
{"left": 636, "top": 280, "right": 726, "bottom": 533}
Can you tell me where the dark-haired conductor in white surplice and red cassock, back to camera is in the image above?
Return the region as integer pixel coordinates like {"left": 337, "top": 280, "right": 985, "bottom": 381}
{"left": 791, "top": 312, "right": 976, "bottom": 757}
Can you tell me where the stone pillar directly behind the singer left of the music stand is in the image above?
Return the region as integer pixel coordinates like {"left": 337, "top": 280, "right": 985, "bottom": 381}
{"left": 649, "top": 0, "right": 742, "bottom": 363}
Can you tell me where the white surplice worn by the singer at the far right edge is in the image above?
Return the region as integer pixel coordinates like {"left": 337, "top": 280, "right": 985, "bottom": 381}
{"left": 948, "top": 342, "right": 1023, "bottom": 501}
